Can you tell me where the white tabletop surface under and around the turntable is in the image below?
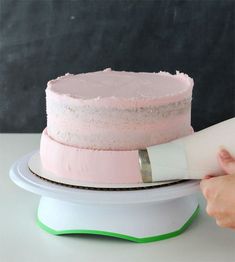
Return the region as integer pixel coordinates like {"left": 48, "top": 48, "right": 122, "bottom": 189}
{"left": 0, "top": 134, "right": 235, "bottom": 262}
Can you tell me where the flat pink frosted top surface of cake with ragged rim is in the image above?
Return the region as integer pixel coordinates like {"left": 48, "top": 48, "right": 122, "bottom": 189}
{"left": 46, "top": 68, "right": 193, "bottom": 107}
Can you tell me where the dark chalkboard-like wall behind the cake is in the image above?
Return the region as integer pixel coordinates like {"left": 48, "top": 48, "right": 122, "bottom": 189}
{"left": 0, "top": 0, "right": 235, "bottom": 132}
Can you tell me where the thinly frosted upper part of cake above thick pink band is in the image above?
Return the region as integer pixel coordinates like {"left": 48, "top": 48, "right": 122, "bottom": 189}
{"left": 46, "top": 69, "right": 193, "bottom": 150}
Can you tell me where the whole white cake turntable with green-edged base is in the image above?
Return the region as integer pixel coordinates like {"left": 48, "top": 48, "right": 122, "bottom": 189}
{"left": 10, "top": 151, "right": 199, "bottom": 243}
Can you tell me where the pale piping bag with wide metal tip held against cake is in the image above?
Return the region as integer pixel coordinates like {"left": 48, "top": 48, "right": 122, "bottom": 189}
{"left": 138, "top": 118, "right": 235, "bottom": 182}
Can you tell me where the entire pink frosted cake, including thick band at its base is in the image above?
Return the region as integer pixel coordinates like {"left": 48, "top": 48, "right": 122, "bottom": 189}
{"left": 40, "top": 69, "right": 193, "bottom": 183}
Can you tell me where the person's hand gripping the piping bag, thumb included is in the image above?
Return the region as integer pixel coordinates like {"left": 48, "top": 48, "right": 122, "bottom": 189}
{"left": 200, "top": 149, "right": 235, "bottom": 229}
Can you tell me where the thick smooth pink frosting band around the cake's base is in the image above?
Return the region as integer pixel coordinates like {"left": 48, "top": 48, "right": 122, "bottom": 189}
{"left": 40, "top": 129, "right": 142, "bottom": 184}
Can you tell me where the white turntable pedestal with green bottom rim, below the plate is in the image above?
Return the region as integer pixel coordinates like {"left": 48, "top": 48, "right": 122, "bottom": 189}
{"left": 37, "top": 195, "right": 199, "bottom": 242}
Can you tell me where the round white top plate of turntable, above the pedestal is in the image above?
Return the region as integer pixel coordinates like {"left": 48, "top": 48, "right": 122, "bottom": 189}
{"left": 10, "top": 152, "right": 199, "bottom": 204}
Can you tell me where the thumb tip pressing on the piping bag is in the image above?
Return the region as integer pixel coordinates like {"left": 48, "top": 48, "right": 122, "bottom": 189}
{"left": 218, "top": 149, "right": 235, "bottom": 175}
